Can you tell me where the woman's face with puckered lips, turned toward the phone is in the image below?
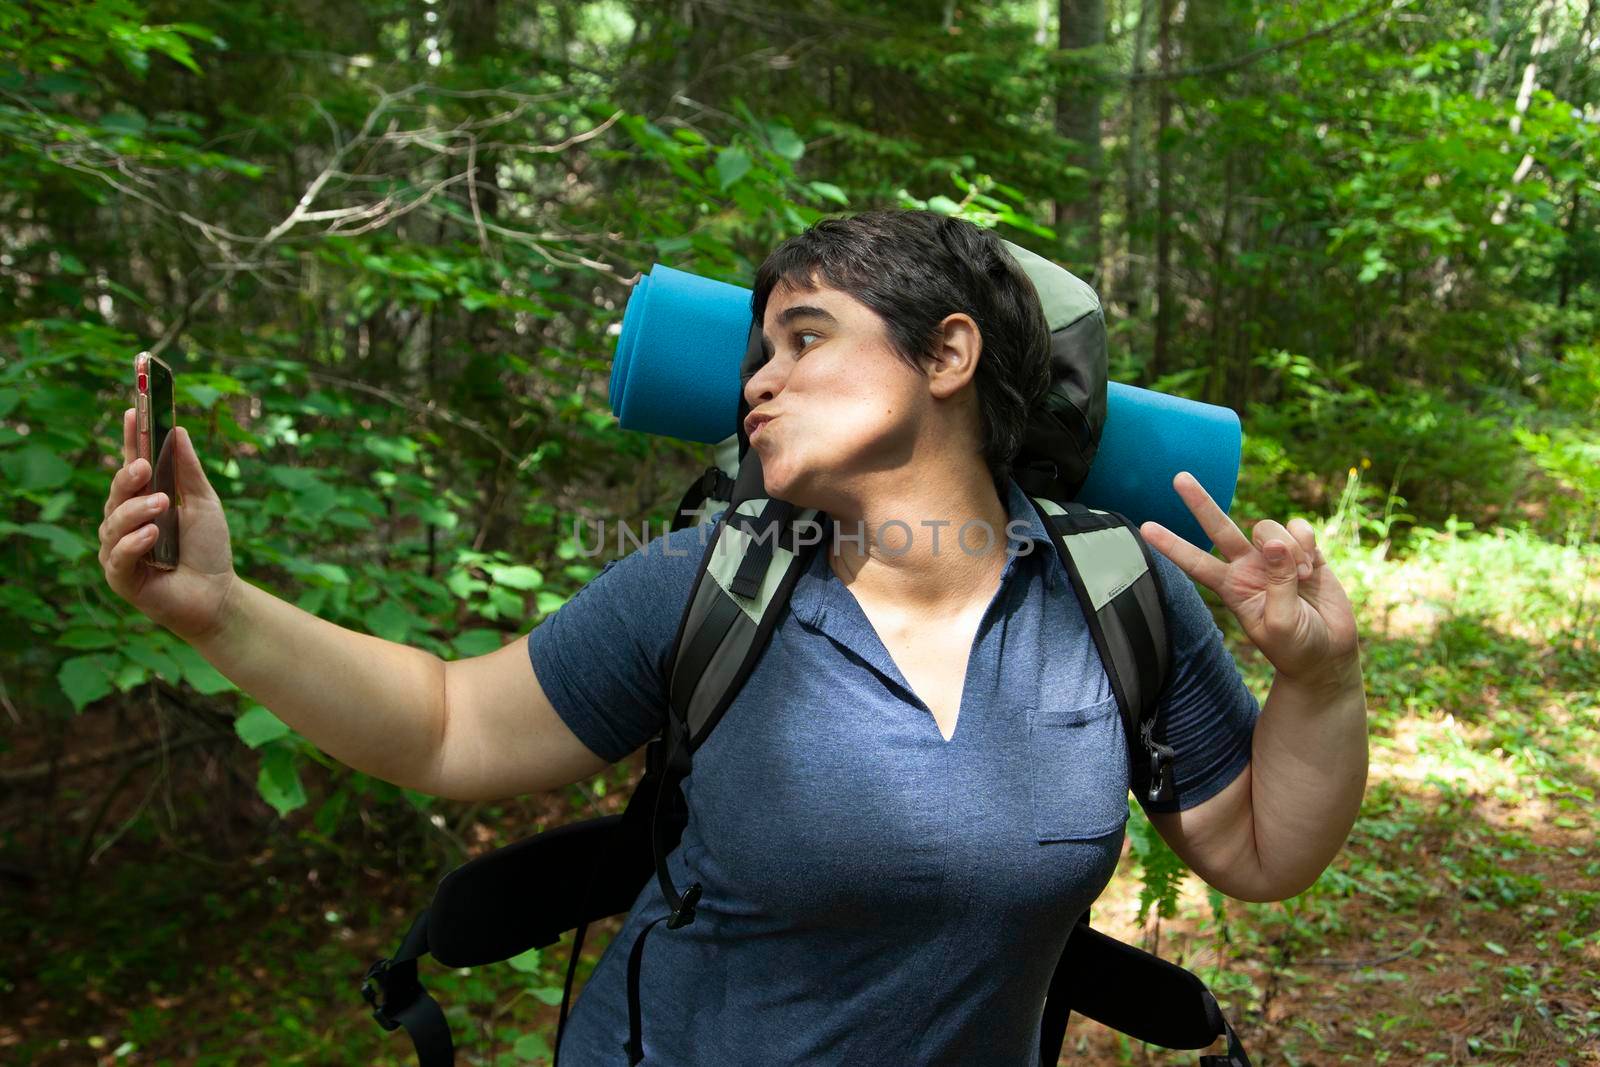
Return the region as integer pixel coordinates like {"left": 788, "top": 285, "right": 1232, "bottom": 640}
{"left": 744, "top": 285, "right": 931, "bottom": 509}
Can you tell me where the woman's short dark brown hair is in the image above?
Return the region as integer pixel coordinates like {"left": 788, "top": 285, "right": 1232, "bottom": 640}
{"left": 750, "top": 211, "right": 1050, "bottom": 501}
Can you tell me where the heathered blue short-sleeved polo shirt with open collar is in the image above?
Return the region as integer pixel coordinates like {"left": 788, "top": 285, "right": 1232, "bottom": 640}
{"left": 528, "top": 480, "right": 1261, "bottom": 1067}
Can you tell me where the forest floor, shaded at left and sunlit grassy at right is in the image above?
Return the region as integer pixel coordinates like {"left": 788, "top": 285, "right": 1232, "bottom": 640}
{"left": 9, "top": 521, "right": 1600, "bottom": 1067}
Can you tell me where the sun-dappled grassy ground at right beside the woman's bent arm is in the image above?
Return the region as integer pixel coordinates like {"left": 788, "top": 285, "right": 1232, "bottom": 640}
{"left": 1062, "top": 536, "right": 1600, "bottom": 1067}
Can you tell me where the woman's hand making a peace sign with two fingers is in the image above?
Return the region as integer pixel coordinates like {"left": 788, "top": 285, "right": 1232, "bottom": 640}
{"left": 1139, "top": 470, "right": 1360, "bottom": 683}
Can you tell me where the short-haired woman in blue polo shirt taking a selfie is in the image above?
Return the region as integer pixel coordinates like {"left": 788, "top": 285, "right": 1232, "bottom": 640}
{"left": 101, "top": 213, "right": 1366, "bottom": 1064}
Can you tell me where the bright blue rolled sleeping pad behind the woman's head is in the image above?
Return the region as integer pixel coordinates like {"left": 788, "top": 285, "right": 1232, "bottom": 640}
{"left": 611, "top": 264, "right": 1243, "bottom": 552}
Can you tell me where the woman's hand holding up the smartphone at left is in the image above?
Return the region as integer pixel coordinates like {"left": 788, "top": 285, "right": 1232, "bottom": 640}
{"left": 99, "top": 408, "right": 237, "bottom": 645}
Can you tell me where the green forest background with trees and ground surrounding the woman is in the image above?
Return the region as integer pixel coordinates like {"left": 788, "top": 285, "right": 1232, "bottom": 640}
{"left": 0, "top": 0, "right": 1600, "bottom": 1064}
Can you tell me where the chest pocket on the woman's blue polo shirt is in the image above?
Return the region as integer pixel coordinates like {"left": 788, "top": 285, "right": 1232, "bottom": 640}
{"left": 1027, "top": 696, "right": 1128, "bottom": 841}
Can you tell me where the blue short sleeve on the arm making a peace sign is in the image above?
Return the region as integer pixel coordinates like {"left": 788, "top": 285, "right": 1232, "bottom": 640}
{"left": 1131, "top": 547, "right": 1261, "bottom": 811}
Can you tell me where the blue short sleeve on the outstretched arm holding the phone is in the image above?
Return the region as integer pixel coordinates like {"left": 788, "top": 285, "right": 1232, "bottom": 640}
{"left": 528, "top": 526, "right": 709, "bottom": 763}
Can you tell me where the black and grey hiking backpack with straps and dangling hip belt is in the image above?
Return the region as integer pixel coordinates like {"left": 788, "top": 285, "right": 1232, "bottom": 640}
{"left": 362, "top": 243, "right": 1250, "bottom": 1067}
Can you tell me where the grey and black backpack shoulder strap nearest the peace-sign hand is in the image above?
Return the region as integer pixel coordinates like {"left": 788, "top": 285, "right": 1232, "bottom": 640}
{"left": 1029, "top": 496, "right": 1174, "bottom": 801}
